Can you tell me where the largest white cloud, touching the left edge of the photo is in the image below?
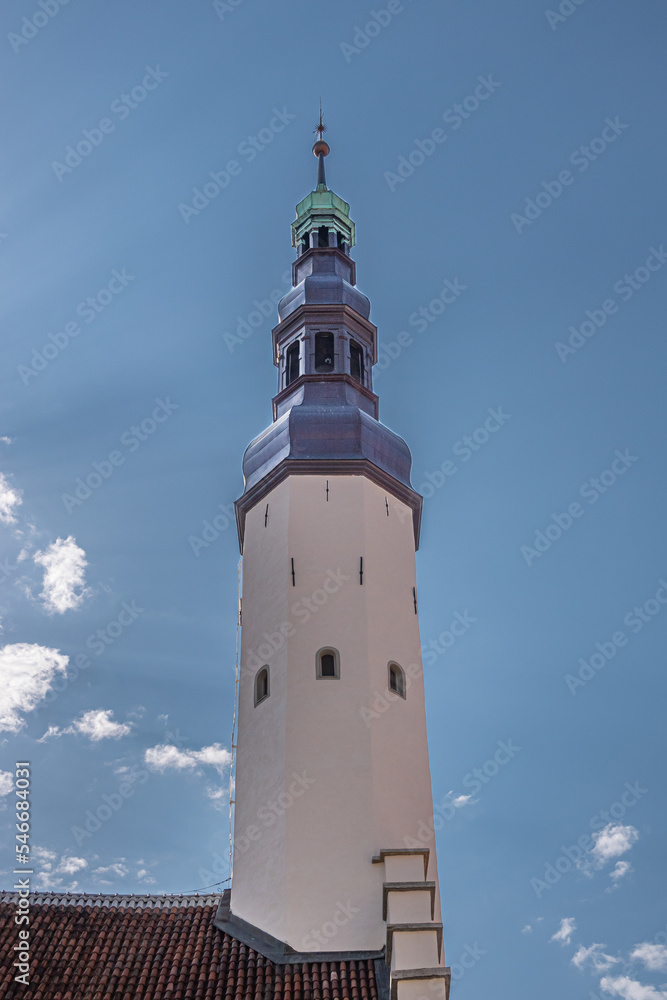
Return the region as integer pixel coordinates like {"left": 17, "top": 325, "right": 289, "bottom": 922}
{"left": 0, "top": 642, "right": 69, "bottom": 733}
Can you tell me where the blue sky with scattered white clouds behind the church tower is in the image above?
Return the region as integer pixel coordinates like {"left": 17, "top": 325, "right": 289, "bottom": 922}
{"left": 0, "top": 0, "right": 667, "bottom": 1000}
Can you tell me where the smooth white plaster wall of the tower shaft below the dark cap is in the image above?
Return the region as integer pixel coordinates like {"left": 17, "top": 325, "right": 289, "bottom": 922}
{"left": 232, "top": 475, "right": 440, "bottom": 951}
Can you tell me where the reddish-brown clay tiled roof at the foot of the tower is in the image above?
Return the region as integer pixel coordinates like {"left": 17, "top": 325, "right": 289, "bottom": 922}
{"left": 0, "top": 892, "right": 378, "bottom": 1000}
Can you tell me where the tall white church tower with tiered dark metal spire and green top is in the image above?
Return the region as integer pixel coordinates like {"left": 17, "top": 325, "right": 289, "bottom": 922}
{"left": 222, "top": 125, "right": 449, "bottom": 1000}
